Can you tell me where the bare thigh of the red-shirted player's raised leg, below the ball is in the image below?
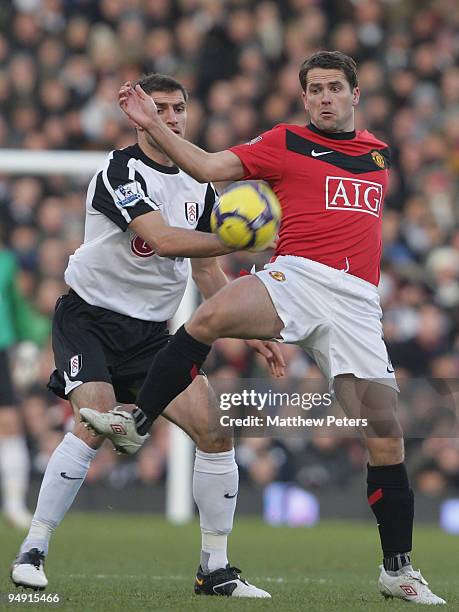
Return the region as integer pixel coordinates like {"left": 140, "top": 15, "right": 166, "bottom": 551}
{"left": 186, "top": 275, "right": 283, "bottom": 342}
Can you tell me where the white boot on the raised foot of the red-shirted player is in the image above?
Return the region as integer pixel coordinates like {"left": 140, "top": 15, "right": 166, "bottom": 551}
{"left": 80, "top": 406, "right": 150, "bottom": 455}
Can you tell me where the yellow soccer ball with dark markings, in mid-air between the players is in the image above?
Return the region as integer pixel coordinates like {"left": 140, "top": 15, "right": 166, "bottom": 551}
{"left": 210, "top": 181, "right": 282, "bottom": 251}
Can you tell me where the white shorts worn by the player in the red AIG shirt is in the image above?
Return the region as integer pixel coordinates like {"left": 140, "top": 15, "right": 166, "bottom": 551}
{"left": 256, "top": 255, "right": 398, "bottom": 390}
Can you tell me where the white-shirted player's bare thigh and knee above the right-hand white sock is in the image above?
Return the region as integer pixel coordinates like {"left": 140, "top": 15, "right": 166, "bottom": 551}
{"left": 162, "top": 376, "right": 233, "bottom": 453}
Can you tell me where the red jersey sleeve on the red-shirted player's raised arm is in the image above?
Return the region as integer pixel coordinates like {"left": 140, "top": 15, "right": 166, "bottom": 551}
{"left": 229, "top": 126, "right": 285, "bottom": 181}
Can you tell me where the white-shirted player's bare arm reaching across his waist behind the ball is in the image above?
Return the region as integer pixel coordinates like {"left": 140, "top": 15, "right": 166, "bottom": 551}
{"left": 129, "top": 211, "right": 236, "bottom": 257}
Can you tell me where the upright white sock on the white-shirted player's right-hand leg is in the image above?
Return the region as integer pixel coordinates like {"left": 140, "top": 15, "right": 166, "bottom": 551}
{"left": 193, "top": 448, "right": 239, "bottom": 573}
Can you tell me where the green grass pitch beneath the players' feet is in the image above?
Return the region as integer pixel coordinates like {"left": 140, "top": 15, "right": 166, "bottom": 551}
{"left": 0, "top": 513, "right": 459, "bottom": 612}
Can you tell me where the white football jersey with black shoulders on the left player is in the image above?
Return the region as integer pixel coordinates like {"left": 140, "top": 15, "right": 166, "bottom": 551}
{"left": 65, "top": 144, "right": 215, "bottom": 321}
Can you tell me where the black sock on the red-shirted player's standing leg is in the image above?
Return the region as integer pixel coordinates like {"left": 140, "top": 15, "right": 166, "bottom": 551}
{"left": 367, "top": 463, "right": 414, "bottom": 571}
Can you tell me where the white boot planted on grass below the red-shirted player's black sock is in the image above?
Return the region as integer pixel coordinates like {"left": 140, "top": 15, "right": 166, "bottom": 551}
{"left": 378, "top": 565, "right": 446, "bottom": 606}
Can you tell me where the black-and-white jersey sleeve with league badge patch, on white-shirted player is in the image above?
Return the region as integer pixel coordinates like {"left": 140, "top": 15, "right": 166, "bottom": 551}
{"left": 91, "top": 151, "right": 159, "bottom": 232}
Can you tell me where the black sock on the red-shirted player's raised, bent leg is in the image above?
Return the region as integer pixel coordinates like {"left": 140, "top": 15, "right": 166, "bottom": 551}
{"left": 134, "top": 325, "right": 211, "bottom": 435}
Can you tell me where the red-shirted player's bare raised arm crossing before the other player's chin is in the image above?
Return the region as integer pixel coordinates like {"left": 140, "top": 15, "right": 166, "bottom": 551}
{"left": 119, "top": 82, "right": 244, "bottom": 183}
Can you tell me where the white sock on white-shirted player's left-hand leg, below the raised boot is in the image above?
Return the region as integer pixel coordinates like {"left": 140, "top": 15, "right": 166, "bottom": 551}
{"left": 21, "top": 433, "right": 97, "bottom": 555}
